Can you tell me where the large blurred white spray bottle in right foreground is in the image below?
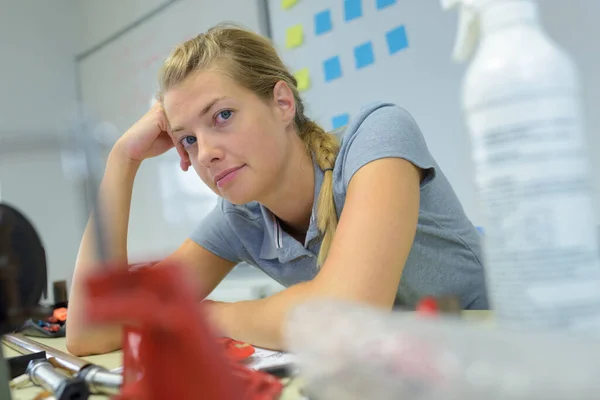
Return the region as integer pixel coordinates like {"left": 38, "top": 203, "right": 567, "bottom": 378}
{"left": 441, "top": 0, "right": 600, "bottom": 330}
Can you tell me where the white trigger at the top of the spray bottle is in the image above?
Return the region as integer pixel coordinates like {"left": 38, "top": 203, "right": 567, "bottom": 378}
{"left": 440, "top": 0, "right": 479, "bottom": 62}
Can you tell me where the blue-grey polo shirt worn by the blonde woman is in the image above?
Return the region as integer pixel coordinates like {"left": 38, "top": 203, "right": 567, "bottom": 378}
{"left": 191, "top": 103, "right": 488, "bottom": 309}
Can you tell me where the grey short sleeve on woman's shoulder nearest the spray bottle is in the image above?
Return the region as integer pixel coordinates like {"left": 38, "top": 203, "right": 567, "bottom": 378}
{"left": 340, "top": 104, "right": 436, "bottom": 187}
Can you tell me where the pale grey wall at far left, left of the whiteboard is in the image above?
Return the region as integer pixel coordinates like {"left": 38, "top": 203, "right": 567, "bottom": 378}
{"left": 0, "top": 0, "right": 82, "bottom": 300}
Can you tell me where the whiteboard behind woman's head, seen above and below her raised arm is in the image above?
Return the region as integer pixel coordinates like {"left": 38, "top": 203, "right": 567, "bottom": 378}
{"left": 78, "top": 0, "right": 265, "bottom": 261}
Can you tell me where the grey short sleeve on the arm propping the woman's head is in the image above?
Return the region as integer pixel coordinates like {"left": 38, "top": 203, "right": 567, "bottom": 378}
{"left": 190, "top": 199, "right": 242, "bottom": 263}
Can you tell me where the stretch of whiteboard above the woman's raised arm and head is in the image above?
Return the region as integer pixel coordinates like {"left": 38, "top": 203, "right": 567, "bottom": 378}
{"left": 79, "top": 0, "right": 263, "bottom": 132}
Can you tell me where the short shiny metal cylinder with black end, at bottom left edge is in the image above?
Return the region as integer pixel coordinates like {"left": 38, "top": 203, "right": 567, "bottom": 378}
{"left": 27, "top": 360, "right": 90, "bottom": 400}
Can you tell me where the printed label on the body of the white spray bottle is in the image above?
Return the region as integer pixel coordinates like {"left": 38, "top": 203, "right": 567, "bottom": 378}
{"left": 468, "top": 93, "right": 600, "bottom": 329}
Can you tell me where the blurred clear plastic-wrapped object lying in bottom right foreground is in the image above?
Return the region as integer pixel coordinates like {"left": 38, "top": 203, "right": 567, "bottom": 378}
{"left": 286, "top": 299, "right": 600, "bottom": 400}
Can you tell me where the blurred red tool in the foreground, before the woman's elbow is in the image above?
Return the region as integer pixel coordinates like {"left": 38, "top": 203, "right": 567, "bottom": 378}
{"left": 87, "top": 264, "right": 283, "bottom": 400}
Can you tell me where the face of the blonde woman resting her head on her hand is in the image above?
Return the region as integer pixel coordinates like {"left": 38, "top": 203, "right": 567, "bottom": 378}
{"left": 163, "top": 71, "right": 295, "bottom": 204}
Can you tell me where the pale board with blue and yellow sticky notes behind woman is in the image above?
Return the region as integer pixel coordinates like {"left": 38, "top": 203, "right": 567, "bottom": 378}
{"left": 269, "top": 0, "right": 480, "bottom": 223}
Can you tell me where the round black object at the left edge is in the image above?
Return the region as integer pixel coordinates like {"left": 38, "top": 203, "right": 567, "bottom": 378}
{"left": 0, "top": 203, "right": 52, "bottom": 335}
